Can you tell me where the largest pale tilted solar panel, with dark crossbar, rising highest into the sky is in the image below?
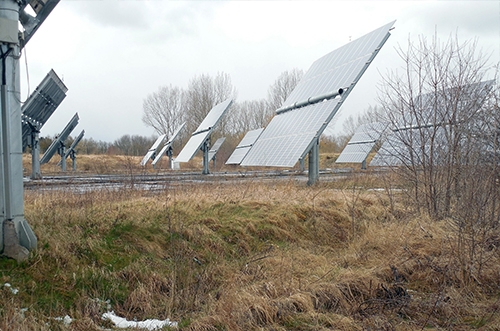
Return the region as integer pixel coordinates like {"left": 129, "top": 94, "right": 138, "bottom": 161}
{"left": 241, "top": 22, "right": 394, "bottom": 167}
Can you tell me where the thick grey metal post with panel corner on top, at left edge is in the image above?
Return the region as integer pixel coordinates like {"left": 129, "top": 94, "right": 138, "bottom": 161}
{"left": 0, "top": 0, "right": 59, "bottom": 261}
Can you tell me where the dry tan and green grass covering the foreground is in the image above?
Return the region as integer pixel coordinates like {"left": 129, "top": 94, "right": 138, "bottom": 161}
{"left": 0, "top": 157, "right": 500, "bottom": 330}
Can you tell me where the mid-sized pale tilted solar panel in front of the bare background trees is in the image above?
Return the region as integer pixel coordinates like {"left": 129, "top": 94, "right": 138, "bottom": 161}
{"left": 175, "top": 99, "right": 233, "bottom": 162}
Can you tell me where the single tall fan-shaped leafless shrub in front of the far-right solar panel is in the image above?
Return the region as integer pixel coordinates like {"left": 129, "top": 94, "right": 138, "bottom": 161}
{"left": 381, "top": 34, "right": 491, "bottom": 218}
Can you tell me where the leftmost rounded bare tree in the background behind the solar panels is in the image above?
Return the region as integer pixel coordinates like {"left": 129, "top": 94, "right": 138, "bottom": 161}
{"left": 142, "top": 85, "right": 185, "bottom": 137}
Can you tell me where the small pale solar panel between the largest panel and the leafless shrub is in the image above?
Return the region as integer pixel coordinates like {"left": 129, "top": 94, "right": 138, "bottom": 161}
{"left": 335, "top": 123, "right": 387, "bottom": 163}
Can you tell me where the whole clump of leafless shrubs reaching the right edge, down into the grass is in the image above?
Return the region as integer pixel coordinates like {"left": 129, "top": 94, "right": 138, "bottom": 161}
{"left": 380, "top": 34, "right": 500, "bottom": 285}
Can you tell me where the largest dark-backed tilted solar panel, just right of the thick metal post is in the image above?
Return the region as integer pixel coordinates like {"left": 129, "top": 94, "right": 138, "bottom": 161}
{"left": 21, "top": 69, "right": 68, "bottom": 150}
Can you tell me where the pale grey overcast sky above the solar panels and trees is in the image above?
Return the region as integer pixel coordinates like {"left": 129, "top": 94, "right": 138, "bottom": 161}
{"left": 21, "top": 0, "right": 500, "bottom": 142}
